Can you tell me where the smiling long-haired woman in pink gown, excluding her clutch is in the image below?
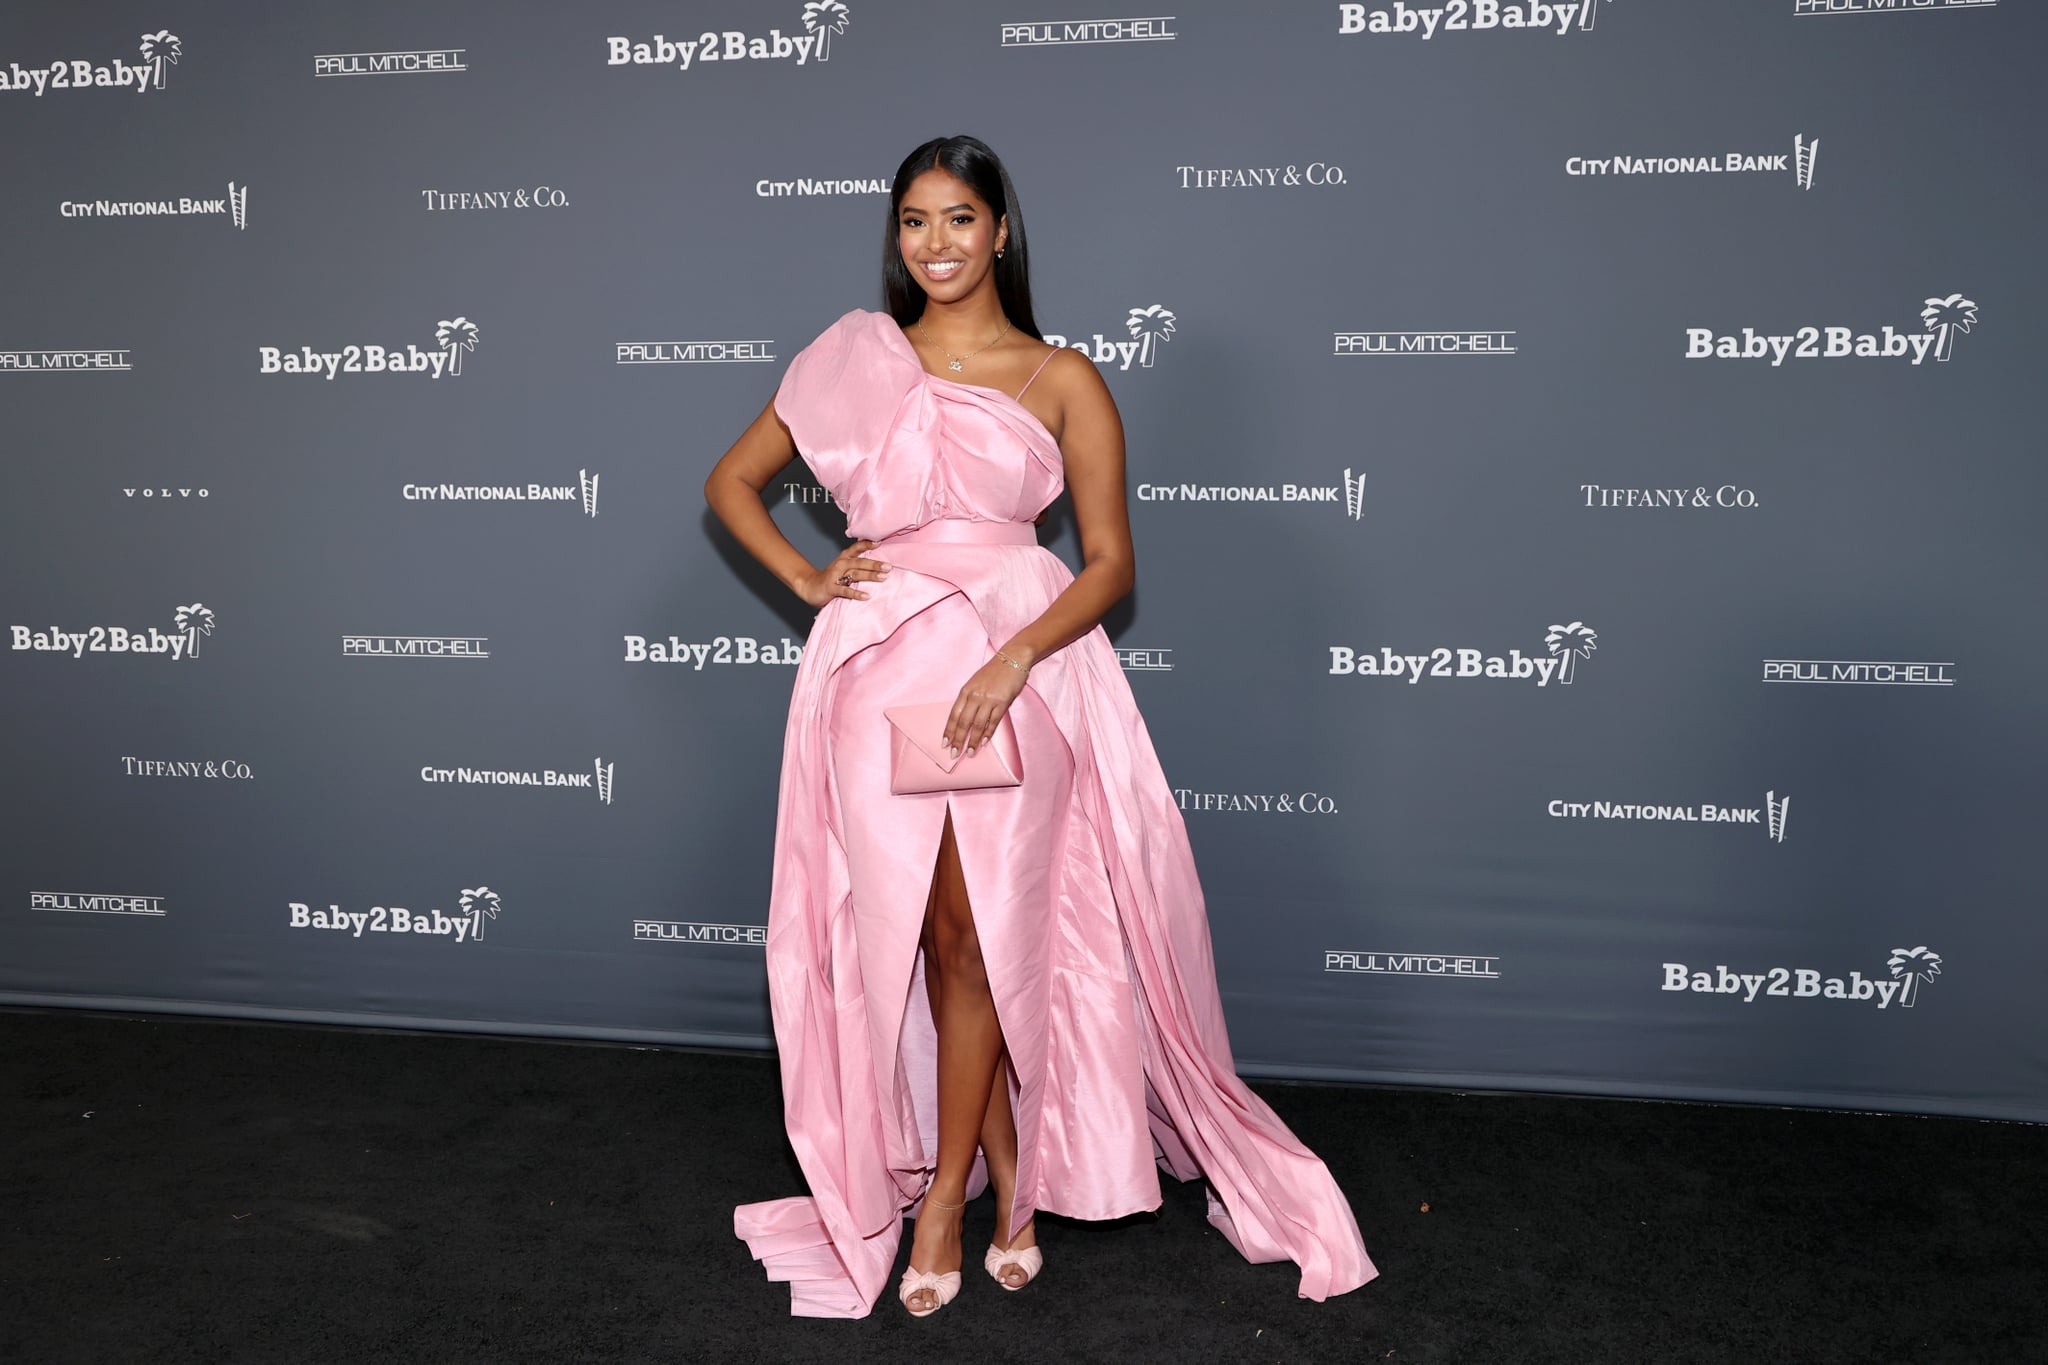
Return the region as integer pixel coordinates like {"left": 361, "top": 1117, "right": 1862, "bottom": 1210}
{"left": 705, "top": 137, "right": 1374, "bottom": 1318}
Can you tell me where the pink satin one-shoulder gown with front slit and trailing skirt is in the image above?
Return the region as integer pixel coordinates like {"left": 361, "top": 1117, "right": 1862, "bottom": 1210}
{"left": 733, "top": 309, "right": 1376, "bottom": 1318}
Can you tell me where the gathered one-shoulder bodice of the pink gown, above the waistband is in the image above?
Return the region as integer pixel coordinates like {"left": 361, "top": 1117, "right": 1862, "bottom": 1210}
{"left": 774, "top": 309, "right": 1065, "bottom": 540}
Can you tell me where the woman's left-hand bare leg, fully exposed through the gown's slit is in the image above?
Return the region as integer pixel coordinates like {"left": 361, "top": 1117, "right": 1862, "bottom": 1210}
{"left": 909, "top": 810, "right": 1016, "bottom": 1310}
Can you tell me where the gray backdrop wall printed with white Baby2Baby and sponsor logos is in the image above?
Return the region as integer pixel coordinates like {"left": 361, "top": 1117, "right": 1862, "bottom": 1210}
{"left": 0, "top": 0, "right": 2048, "bottom": 1119}
